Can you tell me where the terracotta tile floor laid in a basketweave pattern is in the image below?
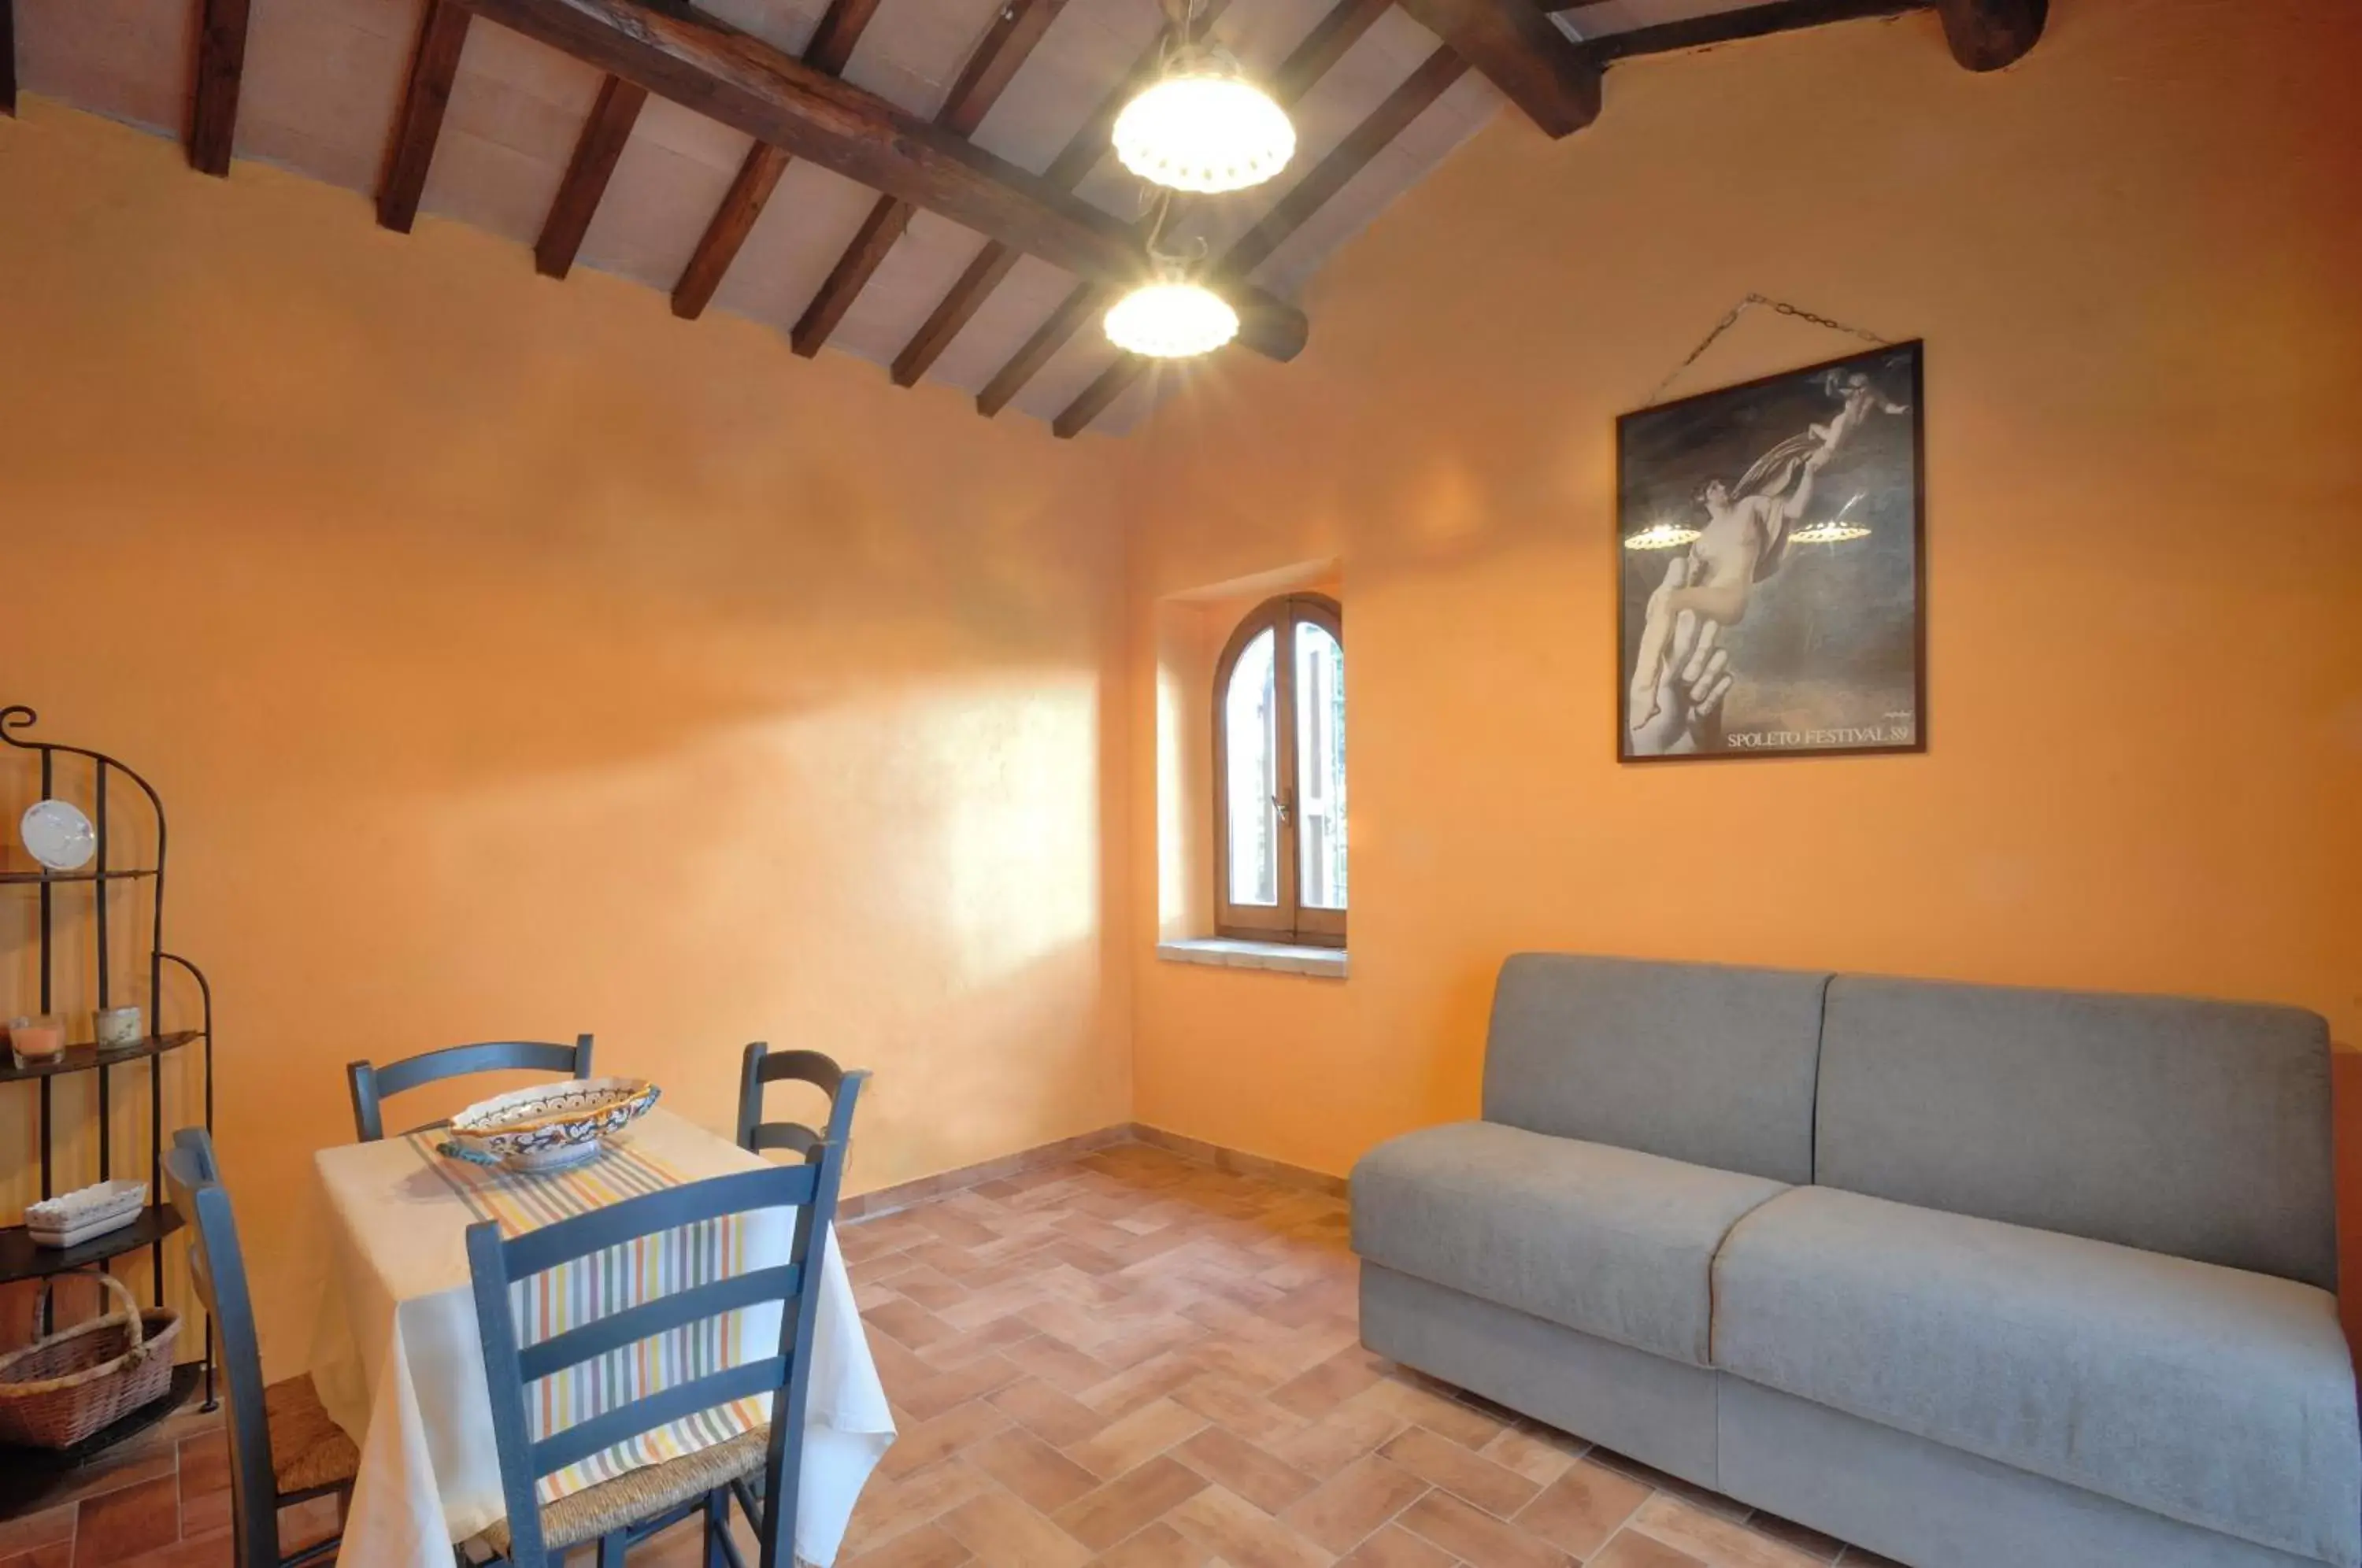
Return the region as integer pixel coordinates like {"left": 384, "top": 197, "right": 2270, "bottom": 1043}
{"left": 0, "top": 1145, "right": 1892, "bottom": 1568}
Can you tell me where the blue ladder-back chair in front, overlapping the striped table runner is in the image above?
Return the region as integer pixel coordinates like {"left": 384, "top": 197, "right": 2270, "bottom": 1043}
{"left": 468, "top": 1115, "right": 846, "bottom": 1568}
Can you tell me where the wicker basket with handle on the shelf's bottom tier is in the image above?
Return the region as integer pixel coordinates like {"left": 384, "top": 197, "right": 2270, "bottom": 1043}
{"left": 0, "top": 1268, "right": 180, "bottom": 1448}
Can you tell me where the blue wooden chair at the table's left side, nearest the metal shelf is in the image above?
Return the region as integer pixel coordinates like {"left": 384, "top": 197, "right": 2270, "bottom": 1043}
{"left": 163, "top": 1126, "right": 361, "bottom": 1568}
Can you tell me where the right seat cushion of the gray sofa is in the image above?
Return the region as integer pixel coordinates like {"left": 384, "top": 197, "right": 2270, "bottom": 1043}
{"left": 1712, "top": 1188, "right": 2362, "bottom": 1568}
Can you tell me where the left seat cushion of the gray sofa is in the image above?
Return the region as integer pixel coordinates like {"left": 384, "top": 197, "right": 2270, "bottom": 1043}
{"left": 1353, "top": 1122, "right": 1783, "bottom": 1367}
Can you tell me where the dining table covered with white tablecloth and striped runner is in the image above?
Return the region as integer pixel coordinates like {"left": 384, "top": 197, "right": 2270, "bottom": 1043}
{"left": 312, "top": 1108, "right": 895, "bottom": 1568}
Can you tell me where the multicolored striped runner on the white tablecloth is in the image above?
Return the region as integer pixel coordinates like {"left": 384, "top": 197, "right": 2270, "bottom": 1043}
{"left": 409, "top": 1129, "right": 770, "bottom": 1504}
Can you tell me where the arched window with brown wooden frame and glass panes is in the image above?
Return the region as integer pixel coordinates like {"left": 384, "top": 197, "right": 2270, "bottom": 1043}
{"left": 1214, "top": 593, "right": 1346, "bottom": 947}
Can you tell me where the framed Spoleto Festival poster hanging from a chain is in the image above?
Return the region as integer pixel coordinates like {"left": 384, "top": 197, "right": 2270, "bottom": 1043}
{"left": 1616, "top": 342, "right": 1927, "bottom": 763}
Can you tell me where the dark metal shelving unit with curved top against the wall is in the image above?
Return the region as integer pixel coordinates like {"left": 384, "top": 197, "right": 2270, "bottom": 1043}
{"left": 0, "top": 706, "right": 213, "bottom": 1490}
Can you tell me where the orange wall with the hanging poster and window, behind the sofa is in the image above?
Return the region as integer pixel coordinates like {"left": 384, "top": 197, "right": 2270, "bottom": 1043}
{"left": 1131, "top": 0, "right": 2362, "bottom": 1171}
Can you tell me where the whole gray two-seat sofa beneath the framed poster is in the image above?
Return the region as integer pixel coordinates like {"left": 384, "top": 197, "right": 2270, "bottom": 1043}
{"left": 1353, "top": 954, "right": 2362, "bottom": 1568}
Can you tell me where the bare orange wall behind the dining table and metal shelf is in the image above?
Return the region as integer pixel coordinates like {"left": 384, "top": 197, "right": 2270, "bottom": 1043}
{"left": 0, "top": 102, "right": 1129, "bottom": 1355}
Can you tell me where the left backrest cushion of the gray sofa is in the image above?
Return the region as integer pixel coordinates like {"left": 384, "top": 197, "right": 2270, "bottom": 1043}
{"left": 1483, "top": 954, "right": 1828, "bottom": 1183}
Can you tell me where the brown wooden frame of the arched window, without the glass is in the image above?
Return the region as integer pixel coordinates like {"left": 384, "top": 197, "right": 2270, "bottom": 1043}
{"left": 1214, "top": 593, "right": 1351, "bottom": 947}
